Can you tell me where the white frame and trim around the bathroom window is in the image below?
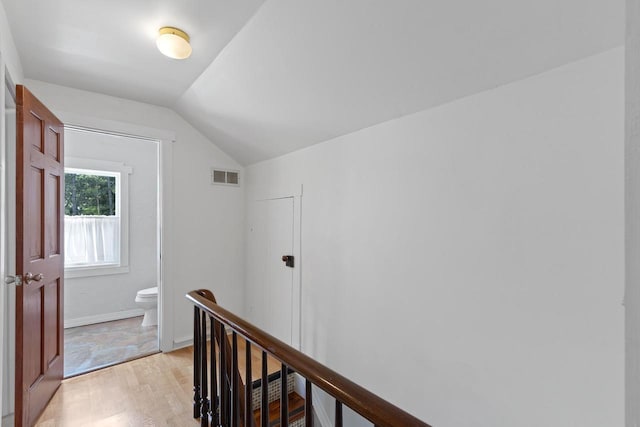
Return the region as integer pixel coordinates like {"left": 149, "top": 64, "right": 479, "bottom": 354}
{"left": 64, "top": 157, "right": 133, "bottom": 279}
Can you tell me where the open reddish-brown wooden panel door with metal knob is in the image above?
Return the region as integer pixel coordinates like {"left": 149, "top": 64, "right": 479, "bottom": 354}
{"left": 15, "top": 85, "right": 64, "bottom": 426}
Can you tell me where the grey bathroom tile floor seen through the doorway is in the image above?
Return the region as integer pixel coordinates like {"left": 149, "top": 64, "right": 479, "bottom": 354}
{"left": 64, "top": 316, "right": 158, "bottom": 378}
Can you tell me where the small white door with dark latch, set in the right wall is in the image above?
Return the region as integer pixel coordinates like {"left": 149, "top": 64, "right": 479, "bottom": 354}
{"left": 247, "top": 197, "right": 296, "bottom": 344}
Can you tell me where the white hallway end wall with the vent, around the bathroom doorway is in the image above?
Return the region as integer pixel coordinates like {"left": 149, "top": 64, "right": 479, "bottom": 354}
{"left": 26, "top": 80, "right": 244, "bottom": 345}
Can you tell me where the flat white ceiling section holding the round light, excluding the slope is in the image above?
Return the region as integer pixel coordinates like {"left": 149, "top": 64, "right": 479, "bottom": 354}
{"left": 2, "top": 0, "right": 263, "bottom": 107}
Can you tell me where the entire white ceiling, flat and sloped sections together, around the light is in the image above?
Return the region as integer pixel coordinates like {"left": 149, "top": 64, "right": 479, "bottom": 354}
{"left": 2, "top": 0, "right": 624, "bottom": 164}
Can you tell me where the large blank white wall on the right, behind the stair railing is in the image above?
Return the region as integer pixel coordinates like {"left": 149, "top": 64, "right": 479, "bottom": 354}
{"left": 246, "top": 48, "right": 624, "bottom": 427}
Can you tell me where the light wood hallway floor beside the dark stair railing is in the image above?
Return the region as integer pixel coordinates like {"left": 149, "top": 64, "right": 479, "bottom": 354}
{"left": 36, "top": 339, "right": 280, "bottom": 427}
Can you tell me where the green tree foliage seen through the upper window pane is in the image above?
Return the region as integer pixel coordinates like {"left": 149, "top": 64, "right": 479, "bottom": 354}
{"left": 64, "top": 173, "right": 116, "bottom": 216}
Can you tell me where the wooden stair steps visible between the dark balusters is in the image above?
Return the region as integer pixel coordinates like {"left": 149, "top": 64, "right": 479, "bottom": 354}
{"left": 228, "top": 337, "right": 305, "bottom": 427}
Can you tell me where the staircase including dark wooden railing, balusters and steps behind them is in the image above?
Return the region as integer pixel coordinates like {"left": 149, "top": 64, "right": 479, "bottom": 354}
{"left": 187, "top": 289, "right": 430, "bottom": 427}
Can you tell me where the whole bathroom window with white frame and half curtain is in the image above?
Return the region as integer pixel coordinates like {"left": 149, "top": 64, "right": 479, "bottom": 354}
{"left": 64, "top": 158, "right": 131, "bottom": 277}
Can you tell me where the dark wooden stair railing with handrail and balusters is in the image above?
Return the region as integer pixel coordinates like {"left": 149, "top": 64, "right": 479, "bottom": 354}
{"left": 187, "top": 289, "right": 430, "bottom": 427}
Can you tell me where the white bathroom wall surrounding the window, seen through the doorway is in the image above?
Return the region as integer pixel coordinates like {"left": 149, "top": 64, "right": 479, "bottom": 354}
{"left": 64, "top": 130, "right": 158, "bottom": 326}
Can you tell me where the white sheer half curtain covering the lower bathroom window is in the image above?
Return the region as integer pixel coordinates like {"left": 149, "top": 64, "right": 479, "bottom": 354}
{"left": 64, "top": 216, "right": 120, "bottom": 267}
